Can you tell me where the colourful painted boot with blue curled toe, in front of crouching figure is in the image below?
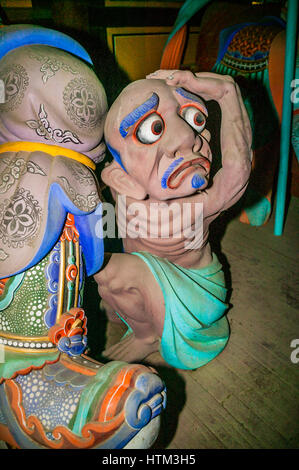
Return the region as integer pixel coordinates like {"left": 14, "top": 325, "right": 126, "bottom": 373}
{"left": 0, "top": 355, "right": 165, "bottom": 449}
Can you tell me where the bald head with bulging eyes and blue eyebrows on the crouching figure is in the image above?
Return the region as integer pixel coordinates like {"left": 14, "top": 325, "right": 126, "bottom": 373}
{"left": 105, "top": 80, "right": 211, "bottom": 200}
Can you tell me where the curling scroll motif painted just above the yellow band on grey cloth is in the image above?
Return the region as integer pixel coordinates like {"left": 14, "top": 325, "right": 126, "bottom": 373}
{"left": 26, "top": 104, "right": 83, "bottom": 144}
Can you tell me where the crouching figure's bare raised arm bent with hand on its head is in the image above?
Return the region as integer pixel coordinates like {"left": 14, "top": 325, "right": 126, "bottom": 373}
{"left": 149, "top": 70, "right": 252, "bottom": 215}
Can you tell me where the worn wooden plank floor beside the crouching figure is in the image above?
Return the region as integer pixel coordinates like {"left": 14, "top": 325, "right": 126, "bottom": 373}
{"left": 108, "top": 198, "right": 299, "bottom": 449}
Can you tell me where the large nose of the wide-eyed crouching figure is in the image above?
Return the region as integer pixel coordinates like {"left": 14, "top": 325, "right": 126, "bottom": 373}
{"left": 163, "top": 116, "right": 197, "bottom": 158}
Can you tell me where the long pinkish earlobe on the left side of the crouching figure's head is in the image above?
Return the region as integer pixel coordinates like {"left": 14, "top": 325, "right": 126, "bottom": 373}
{"left": 101, "top": 161, "right": 147, "bottom": 200}
